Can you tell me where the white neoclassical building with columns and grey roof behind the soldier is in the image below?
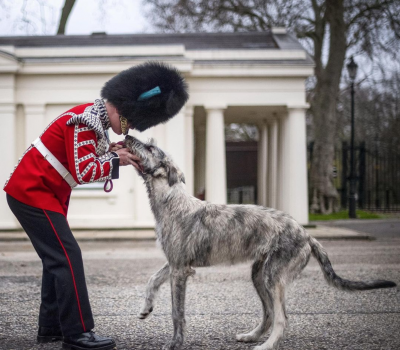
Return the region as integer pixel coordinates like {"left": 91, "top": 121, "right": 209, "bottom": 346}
{"left": 0, "top": 28, "right": 313, "bottom": 229}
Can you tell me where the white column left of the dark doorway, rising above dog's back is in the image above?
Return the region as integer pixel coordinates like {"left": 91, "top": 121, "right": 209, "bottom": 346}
{"left": 206, "top": 108, "right": 227, "bottom": 204}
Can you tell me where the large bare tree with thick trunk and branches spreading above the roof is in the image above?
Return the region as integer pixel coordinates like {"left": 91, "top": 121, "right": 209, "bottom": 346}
{"left": 146, "top": 0, "right": 400, "bottom": 213}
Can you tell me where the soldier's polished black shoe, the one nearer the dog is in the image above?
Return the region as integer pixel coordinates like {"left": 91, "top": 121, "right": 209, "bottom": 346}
{"left": 62, "top": 331, "right": 116, "bottom": 350}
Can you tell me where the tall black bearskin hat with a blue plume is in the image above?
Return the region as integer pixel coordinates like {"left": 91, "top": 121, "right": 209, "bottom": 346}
{"left": 101, "top": 62, "right": 189, "bottom": 131}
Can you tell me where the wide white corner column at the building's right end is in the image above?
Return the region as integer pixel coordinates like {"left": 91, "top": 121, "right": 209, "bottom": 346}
{"left": 282, "top": 108, "right": 308, "bottom": 224}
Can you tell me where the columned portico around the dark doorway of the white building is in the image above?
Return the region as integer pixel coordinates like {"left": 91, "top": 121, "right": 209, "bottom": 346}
{"left": 194, "top": 106, "right": 308, "bottom": 223}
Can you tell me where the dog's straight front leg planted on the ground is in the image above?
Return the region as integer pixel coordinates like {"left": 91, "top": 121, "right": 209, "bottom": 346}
{"left": 163, "top": 267, "right": 193, "bottom": 350}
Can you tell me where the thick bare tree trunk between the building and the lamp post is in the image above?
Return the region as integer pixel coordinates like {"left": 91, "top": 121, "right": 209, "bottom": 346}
{"left": 310, "top": 0, "right": 347, "bottom": 213}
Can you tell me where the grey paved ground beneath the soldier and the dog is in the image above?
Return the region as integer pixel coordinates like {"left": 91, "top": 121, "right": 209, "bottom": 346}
{"left": 0, "top": 221, "right": 400, "bottom": 350}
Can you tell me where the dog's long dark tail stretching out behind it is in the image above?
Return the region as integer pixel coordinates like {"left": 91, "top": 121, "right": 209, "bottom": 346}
{"left": 308, "top": 236, "right": 396, "bottom": 291}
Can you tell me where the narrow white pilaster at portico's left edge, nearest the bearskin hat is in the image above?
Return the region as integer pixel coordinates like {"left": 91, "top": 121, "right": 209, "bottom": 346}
{"left": 185, "top": 106, "right": 194, "bottom": 196}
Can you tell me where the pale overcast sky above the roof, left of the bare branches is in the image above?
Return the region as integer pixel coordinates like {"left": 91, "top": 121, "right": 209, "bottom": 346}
{"left": 0, "top": 0, "right": 154, "bottom": 36}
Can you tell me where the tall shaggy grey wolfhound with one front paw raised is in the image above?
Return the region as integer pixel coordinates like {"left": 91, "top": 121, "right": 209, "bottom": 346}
{"left": 125, "top": 136, "right": 396, "bottom": 350}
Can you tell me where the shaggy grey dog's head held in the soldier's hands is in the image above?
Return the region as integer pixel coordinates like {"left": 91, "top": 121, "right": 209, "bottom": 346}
{"left": 125, "top": 135, "right": 185, "bottom": 187}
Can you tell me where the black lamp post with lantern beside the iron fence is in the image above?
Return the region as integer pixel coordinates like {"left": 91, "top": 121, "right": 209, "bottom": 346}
{"left": 347, "top": 56, "right": 358, "bottom": 219}
